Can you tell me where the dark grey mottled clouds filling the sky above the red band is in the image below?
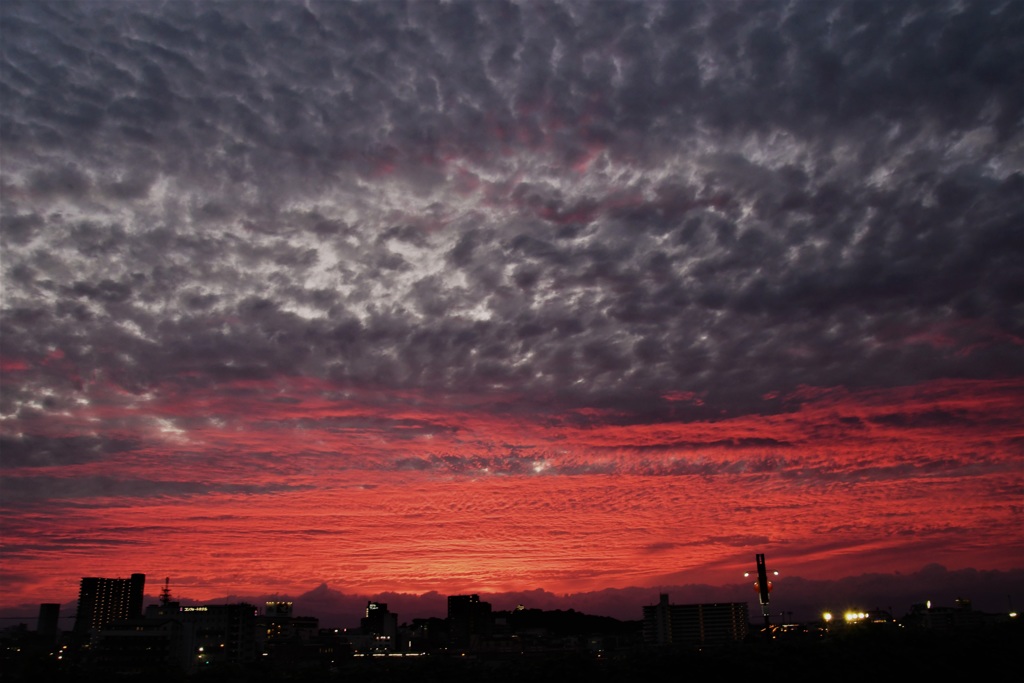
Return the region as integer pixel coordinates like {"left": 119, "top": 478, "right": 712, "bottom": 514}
{"left": 0, "top": 0, "right": 1024, "bottom": 430}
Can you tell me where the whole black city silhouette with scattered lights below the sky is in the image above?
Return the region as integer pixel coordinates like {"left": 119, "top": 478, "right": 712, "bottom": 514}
{"left": 12, "top": 574, "right": 1024, "bottom": 683}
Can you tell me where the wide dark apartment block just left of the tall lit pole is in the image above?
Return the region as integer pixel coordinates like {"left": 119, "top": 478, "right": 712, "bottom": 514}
{"left": 643, "top": 593, "right": 749, "bottom": 646}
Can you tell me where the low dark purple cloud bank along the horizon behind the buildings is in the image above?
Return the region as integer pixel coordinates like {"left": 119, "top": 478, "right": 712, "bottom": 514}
{"left": 0, "top": 566, "right": 1024, "bottom": 631}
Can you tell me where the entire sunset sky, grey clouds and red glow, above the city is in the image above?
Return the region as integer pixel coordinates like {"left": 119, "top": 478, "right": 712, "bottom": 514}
{"left": 0, "top": 0, "right": 1024, "bottom": 617}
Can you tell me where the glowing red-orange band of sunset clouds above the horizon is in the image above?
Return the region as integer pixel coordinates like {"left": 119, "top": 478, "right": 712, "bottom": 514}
{"left": 4, "top": 380, "right": 1024, "bottom": 602}
